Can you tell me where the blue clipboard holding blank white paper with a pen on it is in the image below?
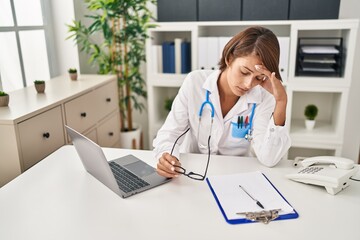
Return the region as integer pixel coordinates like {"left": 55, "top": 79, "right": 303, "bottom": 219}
{"left": 206, "top": 171, "right": 299, "bottom": 224}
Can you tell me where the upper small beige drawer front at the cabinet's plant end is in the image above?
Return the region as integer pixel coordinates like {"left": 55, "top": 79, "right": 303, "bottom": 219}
{"left": 94, "top": 81, "right": 119, "bottom": 121}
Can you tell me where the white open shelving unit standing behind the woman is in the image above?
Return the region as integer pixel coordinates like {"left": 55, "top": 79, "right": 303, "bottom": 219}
{"left": 146, "top": 19, "right": 359, "bottom": 159}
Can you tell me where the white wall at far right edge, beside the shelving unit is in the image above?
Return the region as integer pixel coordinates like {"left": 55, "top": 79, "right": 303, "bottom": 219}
{"left": 339, "top": 0, "right": 360, "bottom": 160}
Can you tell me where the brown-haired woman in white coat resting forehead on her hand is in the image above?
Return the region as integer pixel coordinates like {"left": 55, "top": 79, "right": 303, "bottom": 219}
{"left": 153, "top": 26, "right": 290, "bottom": 178}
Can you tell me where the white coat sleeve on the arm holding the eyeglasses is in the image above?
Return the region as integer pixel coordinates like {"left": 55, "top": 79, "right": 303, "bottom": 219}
{"left": 153, "top": 73, "right": 191, "bottom": 159}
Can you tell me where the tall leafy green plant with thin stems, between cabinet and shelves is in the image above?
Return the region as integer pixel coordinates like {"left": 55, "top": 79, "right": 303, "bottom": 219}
{"left": 68, "top": 0, "right": 156, "bottom": 147}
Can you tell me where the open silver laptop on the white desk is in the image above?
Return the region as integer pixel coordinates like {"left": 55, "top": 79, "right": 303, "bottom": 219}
{"left": 65, "top": 126, "right": 171, "bottom": 198}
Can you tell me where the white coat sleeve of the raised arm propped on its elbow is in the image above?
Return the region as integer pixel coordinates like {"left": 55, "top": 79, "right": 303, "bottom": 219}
{"left": 251, "top": 92, "right": 291, "bottom": 167}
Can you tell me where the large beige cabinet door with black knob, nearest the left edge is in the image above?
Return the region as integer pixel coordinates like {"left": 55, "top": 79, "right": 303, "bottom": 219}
{"left": 18, "top": 106, "right": 65, "bottom": 171}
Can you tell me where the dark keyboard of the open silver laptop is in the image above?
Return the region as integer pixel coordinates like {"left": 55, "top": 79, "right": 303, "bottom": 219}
{"left": 109, "top": 162, "right": 150, "bottom": 193}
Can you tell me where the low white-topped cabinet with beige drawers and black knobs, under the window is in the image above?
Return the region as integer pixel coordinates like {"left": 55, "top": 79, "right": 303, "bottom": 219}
{"left": 0, "top": 75, "right": 120, "bottom": 187}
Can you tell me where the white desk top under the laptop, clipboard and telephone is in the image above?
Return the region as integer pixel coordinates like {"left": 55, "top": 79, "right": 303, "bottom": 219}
{"left": 0, "top": 146, "right": 360, "bottom": 240}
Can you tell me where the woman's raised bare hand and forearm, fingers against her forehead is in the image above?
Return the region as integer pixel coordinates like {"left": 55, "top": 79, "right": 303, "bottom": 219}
{"left": 255, "top": 65, "right": 287, "bottom": 126}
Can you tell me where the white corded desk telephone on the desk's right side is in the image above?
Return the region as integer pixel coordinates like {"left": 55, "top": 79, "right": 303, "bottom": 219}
{"left": 286, "top": 156, "right": 358, "bottom": 195}
